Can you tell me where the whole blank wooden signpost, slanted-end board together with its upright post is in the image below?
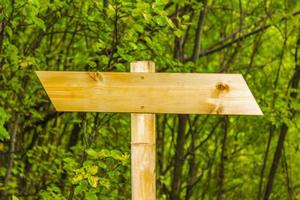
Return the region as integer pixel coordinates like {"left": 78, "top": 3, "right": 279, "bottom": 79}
{"left": 36, "top": 61, "right": 262, "bottom": 200}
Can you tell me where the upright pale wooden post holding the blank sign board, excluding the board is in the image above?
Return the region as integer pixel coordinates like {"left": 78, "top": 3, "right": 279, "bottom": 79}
{"left": 130, "top": 61, "right": 156, "bottom": 200}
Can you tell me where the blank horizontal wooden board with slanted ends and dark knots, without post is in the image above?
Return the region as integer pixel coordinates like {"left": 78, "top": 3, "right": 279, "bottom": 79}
{"left": 37, "top": 71, "right": 262, "bottom": 115}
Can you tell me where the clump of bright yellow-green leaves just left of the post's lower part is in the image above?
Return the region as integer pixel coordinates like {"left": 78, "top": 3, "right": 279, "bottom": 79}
{"left": 66, "top": 149, "right": 129, "bottom": 199}
